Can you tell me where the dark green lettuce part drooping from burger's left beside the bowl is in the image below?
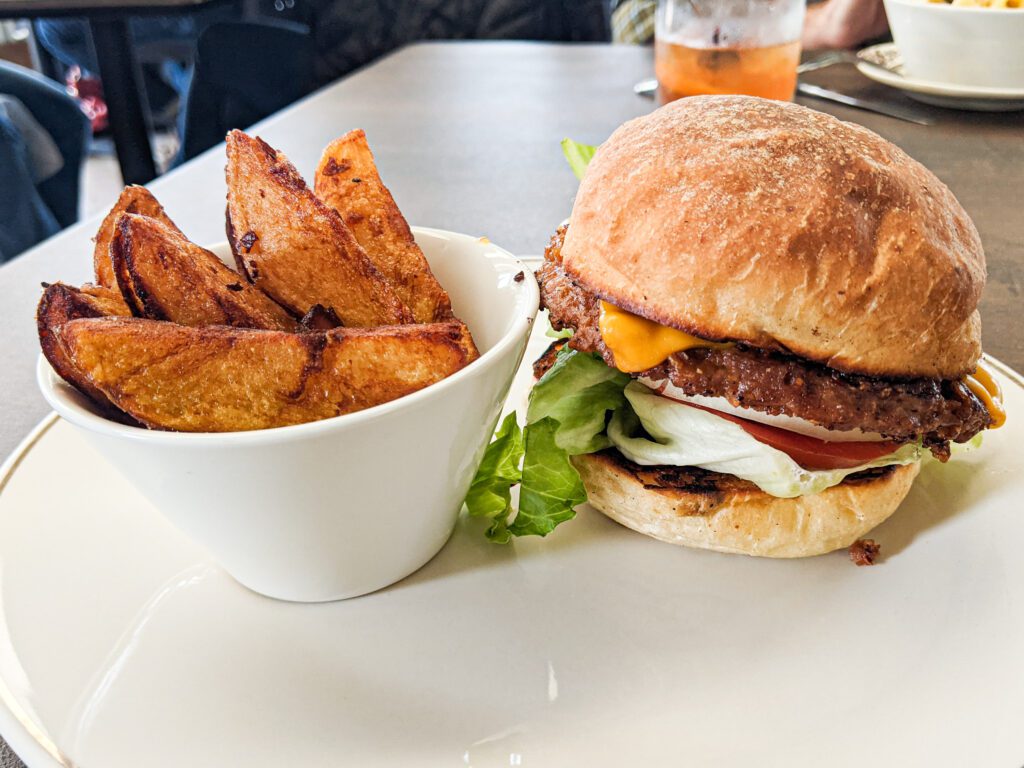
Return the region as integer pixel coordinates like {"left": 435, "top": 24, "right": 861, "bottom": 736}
{"left": 466, "top": 347, "right": 630, "bottom": 543}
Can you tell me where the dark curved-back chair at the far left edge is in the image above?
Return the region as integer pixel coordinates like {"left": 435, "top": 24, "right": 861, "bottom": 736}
{"left": 0, "top": 61, "right": 90, "bottom": 258}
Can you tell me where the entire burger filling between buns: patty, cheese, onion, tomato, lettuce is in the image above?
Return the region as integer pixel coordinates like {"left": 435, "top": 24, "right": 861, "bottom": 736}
{"left": 466, "top": 231, "right": 999, "bottom": 542}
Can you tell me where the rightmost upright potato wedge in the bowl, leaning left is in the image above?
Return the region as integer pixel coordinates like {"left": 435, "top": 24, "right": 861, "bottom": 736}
{"left": 315, "top": 129, "right": 452, "bottom": 323}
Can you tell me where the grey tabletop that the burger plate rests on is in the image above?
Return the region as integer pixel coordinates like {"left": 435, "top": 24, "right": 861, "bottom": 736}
{"left": 0, "top": 43, "right": 1024, "bottom": 768}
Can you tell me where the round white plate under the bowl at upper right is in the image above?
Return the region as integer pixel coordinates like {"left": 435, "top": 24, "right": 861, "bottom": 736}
{"left": 857, "top": 43, "right": 1024, "bottom": 112}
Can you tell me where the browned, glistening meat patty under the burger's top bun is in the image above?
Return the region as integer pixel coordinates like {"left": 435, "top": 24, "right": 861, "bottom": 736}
{"left": 537, "top": 231, "right": 991, "bottom": 460}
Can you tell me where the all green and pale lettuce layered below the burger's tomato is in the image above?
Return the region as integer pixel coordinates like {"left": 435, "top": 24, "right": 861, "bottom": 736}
{"left": 466, "top": 347, "right": 937, "bottom": 543}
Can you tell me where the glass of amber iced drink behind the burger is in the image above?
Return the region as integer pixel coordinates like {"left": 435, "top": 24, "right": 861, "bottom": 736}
{"left": 654, "top": 0, "right": 807, "bottom": 103}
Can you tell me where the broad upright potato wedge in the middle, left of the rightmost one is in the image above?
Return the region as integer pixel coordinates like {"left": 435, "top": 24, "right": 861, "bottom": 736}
{"left": 227, "top": 131, "right": 413, "bottom": 327}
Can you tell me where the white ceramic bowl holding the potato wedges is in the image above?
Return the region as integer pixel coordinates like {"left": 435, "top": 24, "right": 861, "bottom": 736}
{"left": 38, "top": 227, "right": 538, "bottom": 602}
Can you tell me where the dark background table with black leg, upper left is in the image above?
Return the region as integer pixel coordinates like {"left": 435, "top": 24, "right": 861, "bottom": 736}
{"left": 0, "top": 0, "right": 223, "bottom": 184}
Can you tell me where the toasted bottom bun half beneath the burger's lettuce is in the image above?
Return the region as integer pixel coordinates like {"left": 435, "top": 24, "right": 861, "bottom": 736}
{"left": 572, "top": 451, "right": 921, "bottom": 557}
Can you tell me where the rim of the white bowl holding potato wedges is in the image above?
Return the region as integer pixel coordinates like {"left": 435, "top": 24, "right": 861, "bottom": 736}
{"left": 36, "top": 226, "right": 540, "bottom": 446}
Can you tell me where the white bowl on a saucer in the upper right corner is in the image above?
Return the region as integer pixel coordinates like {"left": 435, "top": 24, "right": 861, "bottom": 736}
{"left": 885, "top": 0, "right": 1024, "bottom": 88}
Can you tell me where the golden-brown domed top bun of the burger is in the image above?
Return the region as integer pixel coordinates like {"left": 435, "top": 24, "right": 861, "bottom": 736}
{"left": 562, "top": 96, "right": 985, "bottom": 379}
